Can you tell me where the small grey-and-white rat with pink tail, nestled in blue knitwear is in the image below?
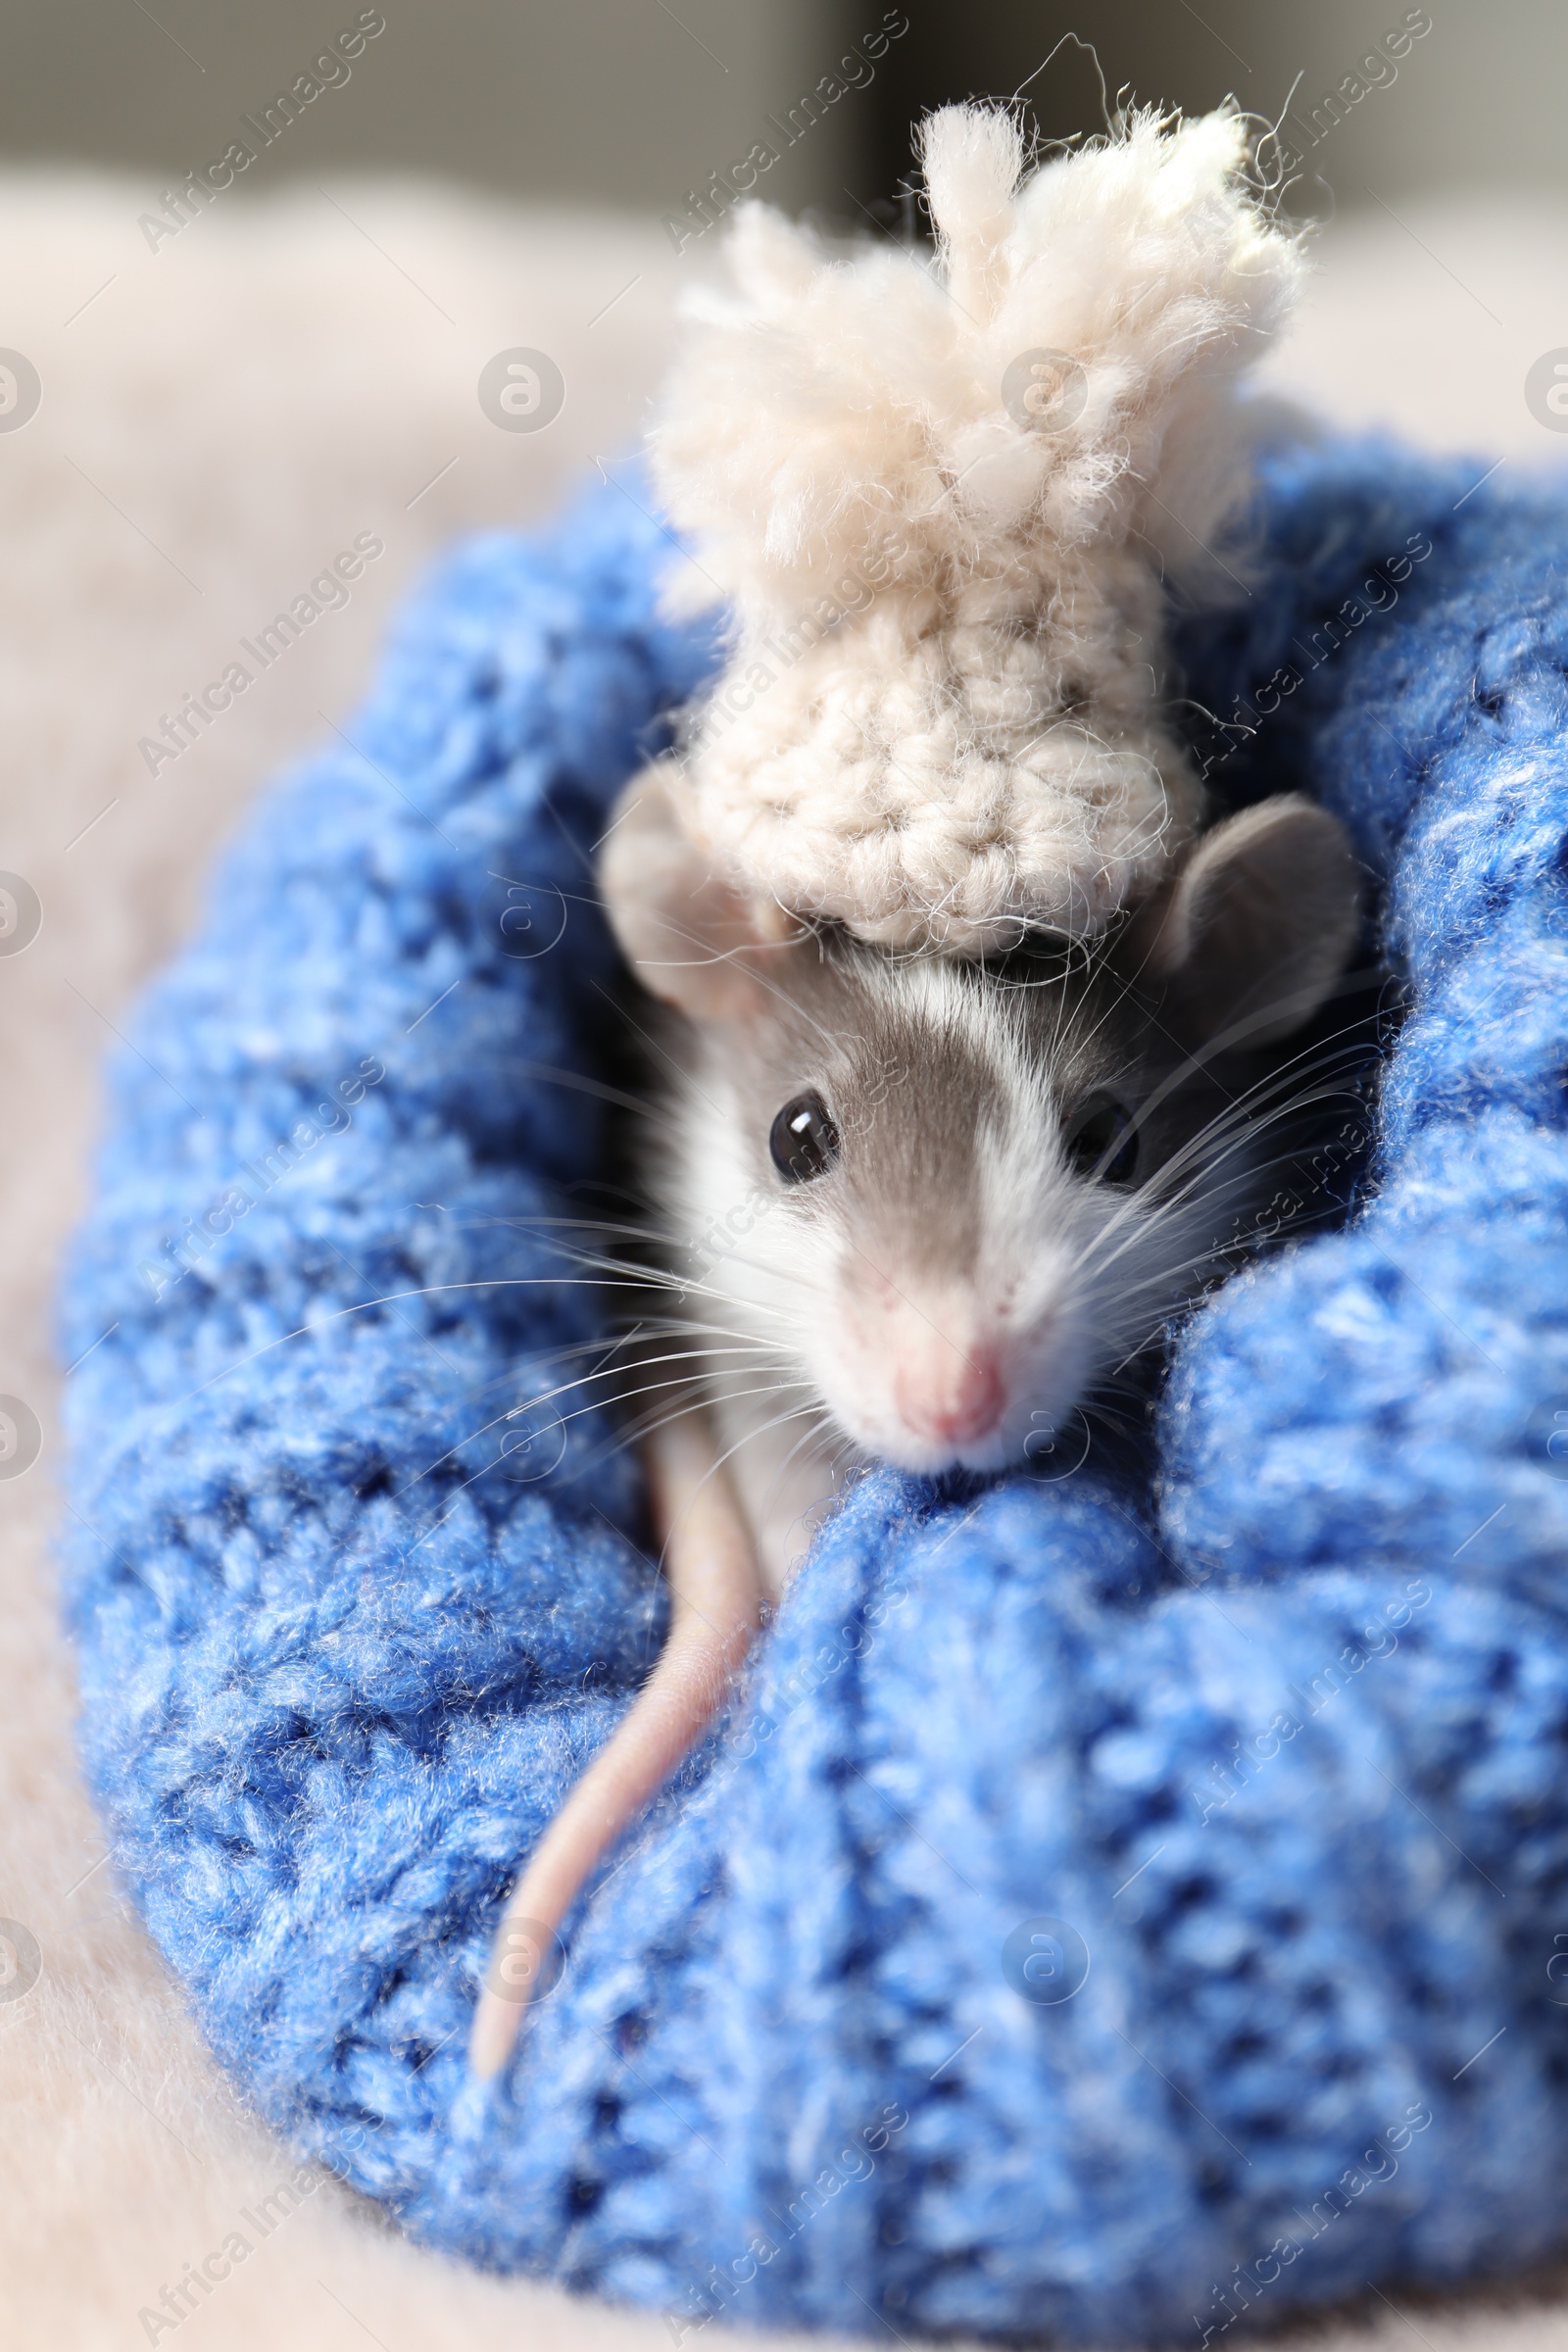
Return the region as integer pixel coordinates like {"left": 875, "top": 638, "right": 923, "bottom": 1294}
{"left": 470, "top": 766, "right": 1361, "bottom": 2077}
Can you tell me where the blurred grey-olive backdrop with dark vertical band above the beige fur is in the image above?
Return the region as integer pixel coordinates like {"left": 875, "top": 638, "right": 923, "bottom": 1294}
{"left": 0, "top": 0, "right": 1568, "bottom": 217}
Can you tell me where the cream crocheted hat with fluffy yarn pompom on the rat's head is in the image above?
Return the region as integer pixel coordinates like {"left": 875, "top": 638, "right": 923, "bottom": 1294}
{"left": 629, "top": 106, "right": 1302, "bottom": 955}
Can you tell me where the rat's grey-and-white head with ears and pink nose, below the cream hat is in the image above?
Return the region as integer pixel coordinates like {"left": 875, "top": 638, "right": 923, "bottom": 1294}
{"left": 604, "top": 776, "right": 1359, "bottom": 1472}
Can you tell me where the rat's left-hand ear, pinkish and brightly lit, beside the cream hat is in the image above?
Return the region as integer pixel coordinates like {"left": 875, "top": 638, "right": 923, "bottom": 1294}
{"left": 600, "top": 766, "right": 790, "bottom": 1021}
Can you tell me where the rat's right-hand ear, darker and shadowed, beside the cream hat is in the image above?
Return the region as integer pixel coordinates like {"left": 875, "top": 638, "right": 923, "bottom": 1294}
{"left": 1128, "top": 793, "right": 1361, "bottom": 1052}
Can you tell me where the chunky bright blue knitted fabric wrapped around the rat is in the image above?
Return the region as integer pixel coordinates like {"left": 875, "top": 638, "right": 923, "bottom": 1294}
{"left": 64, "top": 445, "right": 1568, "bottom": 2340}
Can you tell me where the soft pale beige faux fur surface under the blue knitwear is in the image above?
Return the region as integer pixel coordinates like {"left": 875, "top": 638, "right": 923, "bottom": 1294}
{"left": 0, "top": 156, "right": 1568, "bottom": 2352}
